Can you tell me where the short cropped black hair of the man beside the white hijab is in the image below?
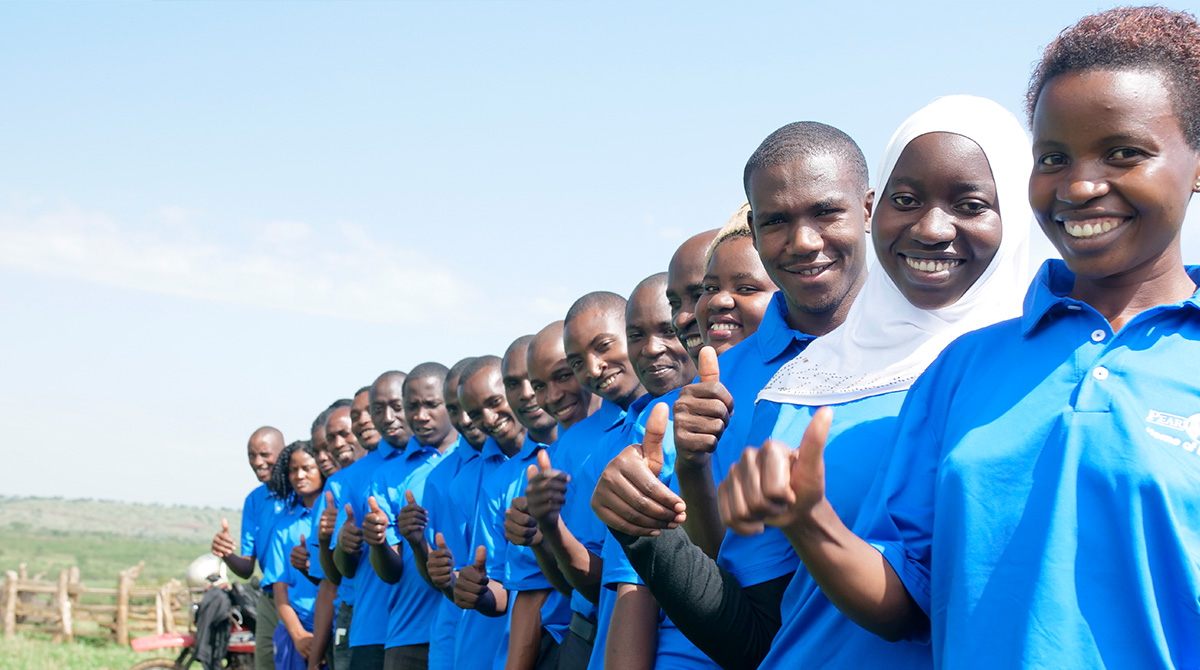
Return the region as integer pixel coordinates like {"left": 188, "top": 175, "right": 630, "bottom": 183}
{"left": 742, "top": 121, "right": 870, "bottom": 198}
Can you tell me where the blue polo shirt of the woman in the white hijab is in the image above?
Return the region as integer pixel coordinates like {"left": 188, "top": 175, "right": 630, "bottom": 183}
{"left": 750, "top": 391, "right": 934, "bottom": 670}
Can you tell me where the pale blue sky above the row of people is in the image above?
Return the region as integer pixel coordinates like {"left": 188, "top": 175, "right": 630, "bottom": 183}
{"left": 0, "top": 1, "right": 1200, "bottom": 506}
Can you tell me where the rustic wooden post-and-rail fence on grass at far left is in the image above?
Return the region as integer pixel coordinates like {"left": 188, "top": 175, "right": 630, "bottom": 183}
{"left": 0, "top": 563, "right": 203, "bottom": 646}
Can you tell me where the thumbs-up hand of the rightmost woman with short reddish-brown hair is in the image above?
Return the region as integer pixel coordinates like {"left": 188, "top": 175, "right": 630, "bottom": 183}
{"left": 718, "top": 407, "right": 833, "bottom": 536}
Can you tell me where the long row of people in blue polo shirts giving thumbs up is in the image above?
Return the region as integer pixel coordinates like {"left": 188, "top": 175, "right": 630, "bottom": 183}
{"left": 214, "top": 7, "right": 1200, "bottom": 670}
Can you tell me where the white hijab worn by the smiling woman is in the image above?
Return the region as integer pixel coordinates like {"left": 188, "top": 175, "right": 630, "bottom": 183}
{"left": 758, "top": 95, "right": 1033, "bottom": 406}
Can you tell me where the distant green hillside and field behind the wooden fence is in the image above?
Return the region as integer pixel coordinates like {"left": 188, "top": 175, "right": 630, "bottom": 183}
{"left": 0, "top": 497, "right": 248, "bottom": 586}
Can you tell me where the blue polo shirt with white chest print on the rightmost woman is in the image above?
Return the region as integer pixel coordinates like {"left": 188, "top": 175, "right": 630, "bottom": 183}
{"left": 856, "top": 261, "right": 1200, "bottom": 670}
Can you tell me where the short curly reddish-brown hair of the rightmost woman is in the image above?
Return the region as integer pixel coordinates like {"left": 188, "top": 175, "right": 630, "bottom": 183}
{"left": 1025, "top": 7, "right": 1200, "bottom": 149}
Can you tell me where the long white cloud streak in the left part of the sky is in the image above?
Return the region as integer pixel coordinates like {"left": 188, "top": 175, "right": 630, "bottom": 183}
{"left": 0, "top": 203, "right": 475, "bottom": 323}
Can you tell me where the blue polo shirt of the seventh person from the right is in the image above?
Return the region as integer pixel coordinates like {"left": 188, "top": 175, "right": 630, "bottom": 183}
{"left": 551, "top": 400, "right": 626, "bottom": 624}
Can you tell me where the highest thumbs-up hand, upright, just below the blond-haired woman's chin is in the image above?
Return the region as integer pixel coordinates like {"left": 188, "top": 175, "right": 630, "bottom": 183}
{"left": 674, "top": 347, "right": 733, "bottom": 467}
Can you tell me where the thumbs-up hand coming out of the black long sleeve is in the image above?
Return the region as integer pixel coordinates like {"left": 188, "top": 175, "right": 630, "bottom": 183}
{"left": 592, "top": 402, "right": 686, "bottom": 536}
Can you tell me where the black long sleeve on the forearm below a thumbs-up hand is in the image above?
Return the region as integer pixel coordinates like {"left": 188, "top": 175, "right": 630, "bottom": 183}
{"left": 612, "top": 528, "right": 793, "bottom": 670}
